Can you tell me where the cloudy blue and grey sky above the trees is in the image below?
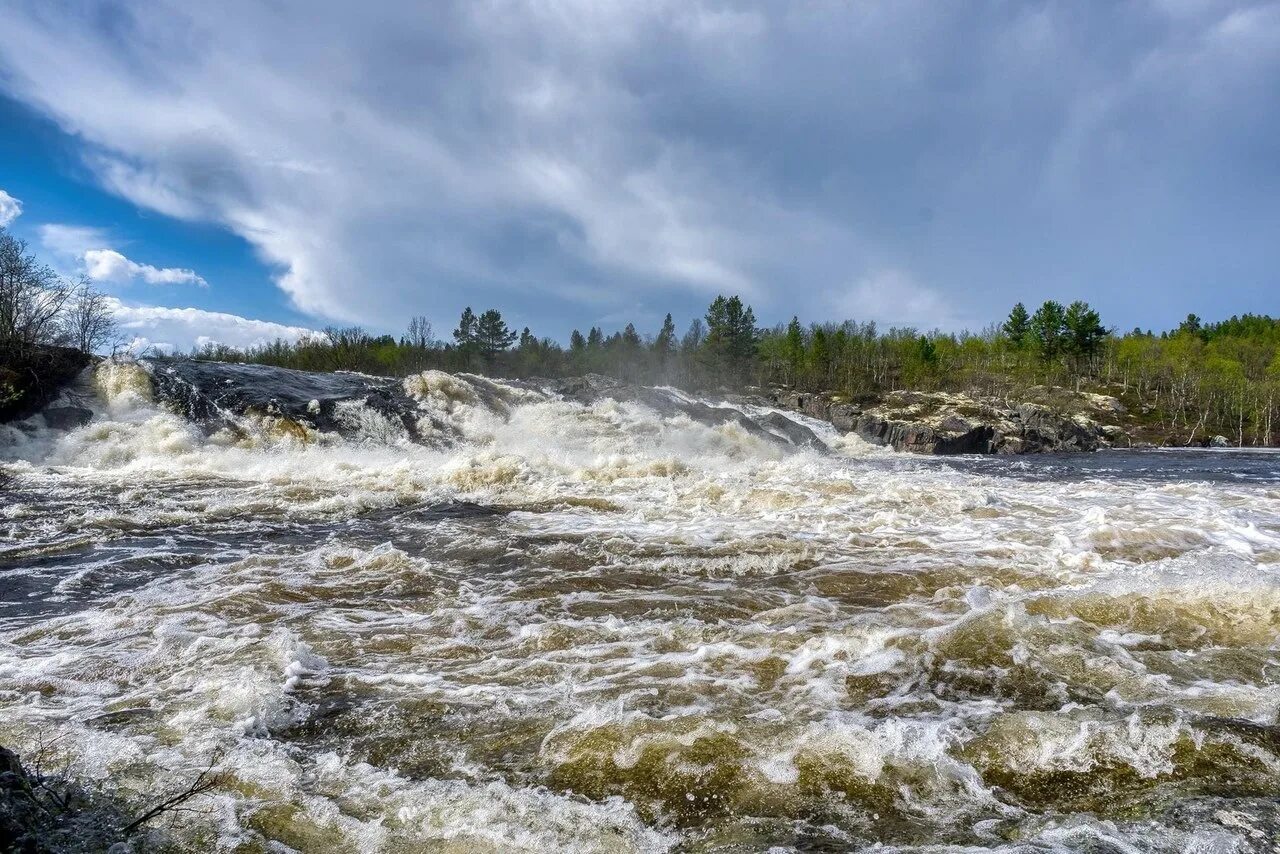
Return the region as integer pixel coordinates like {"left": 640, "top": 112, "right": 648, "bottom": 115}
{"left": 0, "top": 0, "right": 1280, "bottom": 348}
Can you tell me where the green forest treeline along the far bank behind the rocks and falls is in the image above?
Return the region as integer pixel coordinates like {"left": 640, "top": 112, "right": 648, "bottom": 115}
{"left": 193, "top": 296, "right": 1280, "bottom": 446}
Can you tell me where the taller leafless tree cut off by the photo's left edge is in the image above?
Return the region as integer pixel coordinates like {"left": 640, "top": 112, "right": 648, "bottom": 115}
{"left": 0, "top": 228, "right": 72, "bottom": 353}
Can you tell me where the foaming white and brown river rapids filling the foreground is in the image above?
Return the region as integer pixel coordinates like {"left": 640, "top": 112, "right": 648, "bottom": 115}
{"left": 0, "top": 364, "right": 1280, "bottom": 853}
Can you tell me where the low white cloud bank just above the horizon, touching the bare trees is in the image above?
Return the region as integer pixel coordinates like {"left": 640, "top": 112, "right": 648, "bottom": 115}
{"left": 109, "top": 297, "right": 320, "bottom": 352}
